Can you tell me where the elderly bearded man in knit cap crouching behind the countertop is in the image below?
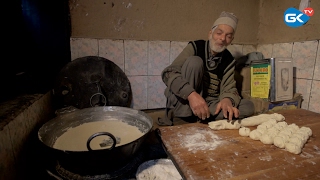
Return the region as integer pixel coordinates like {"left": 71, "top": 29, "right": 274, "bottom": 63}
{"left": 157, "top": 12, "right": 254, "bottom": 125}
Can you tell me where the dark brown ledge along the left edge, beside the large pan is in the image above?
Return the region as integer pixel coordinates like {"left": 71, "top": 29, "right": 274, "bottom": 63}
{"left": 0, "top": 92, "right": 54, "bottom": 179}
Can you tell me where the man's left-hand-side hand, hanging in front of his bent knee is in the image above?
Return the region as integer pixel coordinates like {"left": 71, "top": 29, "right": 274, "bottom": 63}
{"left": 188, "top": 92, "right": 210, "bottom": 120}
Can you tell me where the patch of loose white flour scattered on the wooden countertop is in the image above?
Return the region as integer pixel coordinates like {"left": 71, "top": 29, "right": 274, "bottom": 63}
{"left": 182, "top": 130, "right": 223, "bottom": 151}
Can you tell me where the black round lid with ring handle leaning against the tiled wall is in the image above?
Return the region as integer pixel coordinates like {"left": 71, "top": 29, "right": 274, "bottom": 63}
{"left": 53, "top": 56, "right": 132, "bottom": 109}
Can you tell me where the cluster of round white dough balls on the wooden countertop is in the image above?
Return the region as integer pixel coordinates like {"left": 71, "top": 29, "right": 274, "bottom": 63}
{"left": 239, "top": 119, "right": 312, "bottom": 154}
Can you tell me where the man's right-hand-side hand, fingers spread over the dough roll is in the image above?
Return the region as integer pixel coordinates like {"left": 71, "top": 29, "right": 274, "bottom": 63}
{"left": 215, "top": 98, "right": 239, "bottom": 121}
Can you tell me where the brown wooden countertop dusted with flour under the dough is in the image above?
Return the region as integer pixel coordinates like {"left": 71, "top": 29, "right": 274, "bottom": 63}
{"left": 158, "top": 109, "right": 320, "bottom": 180}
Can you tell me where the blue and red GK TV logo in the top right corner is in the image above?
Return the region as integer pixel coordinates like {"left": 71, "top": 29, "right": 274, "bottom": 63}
{"left": 284, "top": 7, "right": 314, "bottom": 28}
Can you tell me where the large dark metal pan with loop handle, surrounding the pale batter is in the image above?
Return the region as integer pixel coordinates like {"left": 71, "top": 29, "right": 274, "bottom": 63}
{"left": 38, "top": 106, "right": 153, "bottom": 175}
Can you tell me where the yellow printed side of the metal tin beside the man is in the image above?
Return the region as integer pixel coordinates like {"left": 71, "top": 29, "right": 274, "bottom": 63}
{"left": 251, "top": 64, "right": 271, "bottom": 99}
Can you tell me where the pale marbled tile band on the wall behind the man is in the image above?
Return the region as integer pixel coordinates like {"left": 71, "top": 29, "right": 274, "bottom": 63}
{"left": 70, "top": 38, "right": 320, "bottom": 113}
